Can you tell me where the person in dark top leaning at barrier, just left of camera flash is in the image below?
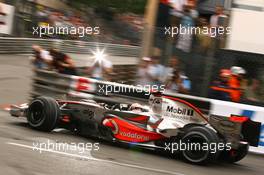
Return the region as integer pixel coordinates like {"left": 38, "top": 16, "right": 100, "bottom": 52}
{"left": 50, "top": 49, "right": 77, "bottom": 75}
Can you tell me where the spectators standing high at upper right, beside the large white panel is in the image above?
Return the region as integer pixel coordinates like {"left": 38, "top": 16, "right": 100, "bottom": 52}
{"left": 161, "top": 0, "right": 228, "bottom": 54}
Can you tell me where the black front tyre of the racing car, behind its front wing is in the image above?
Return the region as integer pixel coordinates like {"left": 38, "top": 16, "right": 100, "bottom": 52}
{"left": 27, "top": 97, "right": 60, "bottom": 132}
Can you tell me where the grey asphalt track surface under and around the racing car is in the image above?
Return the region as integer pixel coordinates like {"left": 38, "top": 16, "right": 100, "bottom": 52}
{"left": 0, "top": 55, "right": 264, "bottom": 175}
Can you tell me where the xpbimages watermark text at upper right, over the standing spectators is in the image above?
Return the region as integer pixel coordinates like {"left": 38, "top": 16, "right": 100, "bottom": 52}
{"left": 164, "top": 24, "right": 231, "bottom": 37}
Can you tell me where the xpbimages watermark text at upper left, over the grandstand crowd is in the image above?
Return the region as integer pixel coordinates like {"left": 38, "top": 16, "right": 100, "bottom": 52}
{"left": 32, "top": 24, "right": 100, "bottom": 38}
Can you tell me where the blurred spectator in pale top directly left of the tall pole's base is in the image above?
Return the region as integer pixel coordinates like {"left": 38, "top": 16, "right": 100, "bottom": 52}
{"left": 137, "top": 57, "right": 151, "bottom": 86}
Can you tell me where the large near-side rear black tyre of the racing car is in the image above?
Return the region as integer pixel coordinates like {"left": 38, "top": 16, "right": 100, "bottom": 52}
{"left": 181, "top": 126, "right": 220, "bottom": 164}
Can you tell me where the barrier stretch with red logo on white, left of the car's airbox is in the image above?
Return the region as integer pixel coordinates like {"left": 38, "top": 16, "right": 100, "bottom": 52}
{"left": 30, "top": 70, "right": 148, "bottom": 103}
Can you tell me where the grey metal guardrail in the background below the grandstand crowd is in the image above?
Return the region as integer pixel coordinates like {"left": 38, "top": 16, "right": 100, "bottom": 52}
{"left": 0, "top": 37, "right": 140, "bottom": 57}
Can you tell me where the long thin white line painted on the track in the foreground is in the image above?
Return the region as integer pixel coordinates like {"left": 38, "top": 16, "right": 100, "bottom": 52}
{"left": 6, "top": 142, "right": 184, "bottom": 175}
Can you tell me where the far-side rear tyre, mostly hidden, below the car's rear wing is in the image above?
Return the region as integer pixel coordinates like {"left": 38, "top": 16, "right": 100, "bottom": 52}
{"left": 220, "top": 144, "right": 249, "bottom": 163}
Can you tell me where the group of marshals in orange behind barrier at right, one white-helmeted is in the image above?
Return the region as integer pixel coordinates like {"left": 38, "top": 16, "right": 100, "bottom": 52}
{"left": 209, "top": 66, "right": 264, "bottom": 104}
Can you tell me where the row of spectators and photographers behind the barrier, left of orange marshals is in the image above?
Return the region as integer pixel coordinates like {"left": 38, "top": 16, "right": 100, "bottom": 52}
{"left": 32, "top": 45, "right": 191, "bottom": 94}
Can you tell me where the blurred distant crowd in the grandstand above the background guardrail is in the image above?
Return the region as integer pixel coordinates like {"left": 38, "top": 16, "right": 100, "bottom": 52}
{"left": 34, "top": 6, "right": 143, "bottom": 45}
